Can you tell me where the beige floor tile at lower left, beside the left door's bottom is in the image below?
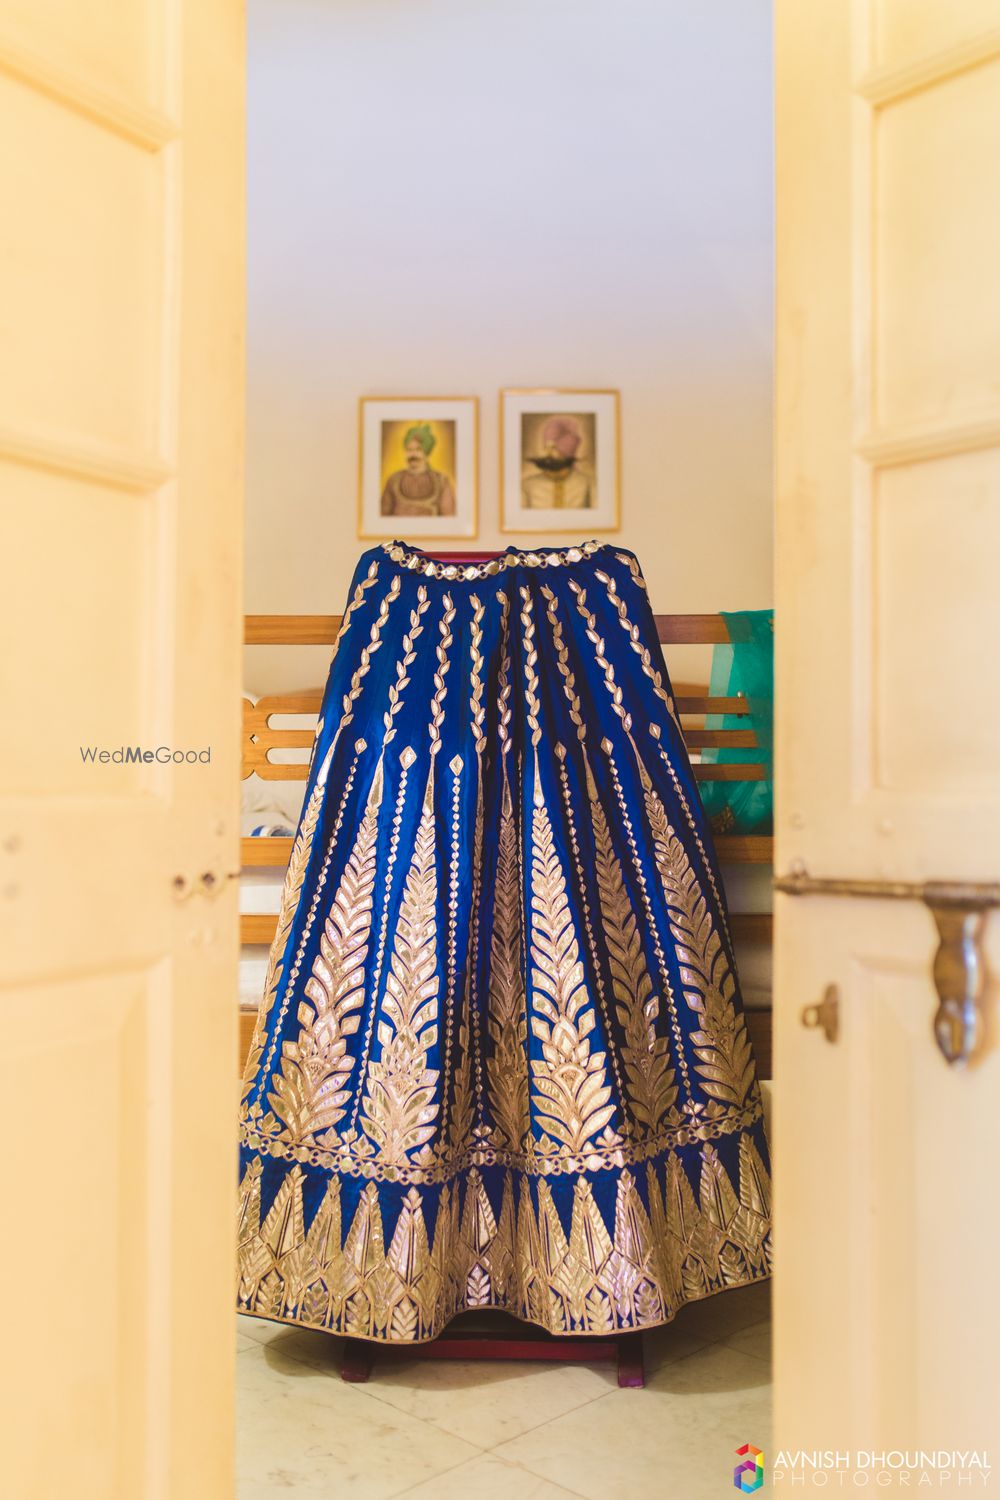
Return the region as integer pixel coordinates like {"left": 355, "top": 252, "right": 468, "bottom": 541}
{"left": 237, "top": 1331, "right": 478, "bottom": 1500}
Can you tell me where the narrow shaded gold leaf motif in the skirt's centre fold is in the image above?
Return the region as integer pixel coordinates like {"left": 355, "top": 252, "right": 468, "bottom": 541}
{"left": 486, "top": 777, "right": 529, "bottom": 1151}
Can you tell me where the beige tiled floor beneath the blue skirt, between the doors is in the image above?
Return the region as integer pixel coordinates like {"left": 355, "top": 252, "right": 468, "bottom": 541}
{"left": 237, "top": 1286, "right": 771, "bottom": 1500}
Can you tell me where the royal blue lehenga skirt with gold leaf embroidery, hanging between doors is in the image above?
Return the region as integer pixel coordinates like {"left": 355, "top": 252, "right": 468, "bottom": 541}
{"left": 238, "top": 543, "right": 771, "bottom": 1343}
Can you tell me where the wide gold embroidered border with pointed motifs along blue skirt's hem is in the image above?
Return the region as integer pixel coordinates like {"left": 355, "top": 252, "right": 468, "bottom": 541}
{"left": 237, "top": 1136, "right": 771, "bottom": 1344}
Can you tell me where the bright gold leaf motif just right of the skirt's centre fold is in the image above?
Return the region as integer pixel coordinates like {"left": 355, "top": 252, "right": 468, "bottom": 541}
{"left": 531, "top": 770, "right": 615, "bottom": 1151}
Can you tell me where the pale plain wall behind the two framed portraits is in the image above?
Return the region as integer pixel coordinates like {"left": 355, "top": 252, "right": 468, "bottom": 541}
{"left": 246, "top": 0, "right": 772, "bottom": 690}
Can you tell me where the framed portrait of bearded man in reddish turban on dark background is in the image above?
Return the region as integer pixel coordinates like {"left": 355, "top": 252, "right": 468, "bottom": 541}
{"left": 499, "top": 389, "right": 621, "bottom": 537}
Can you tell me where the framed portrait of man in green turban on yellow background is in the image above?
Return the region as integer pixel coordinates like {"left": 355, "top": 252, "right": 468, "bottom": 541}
{"left": 358, "top": 396, "right": 480, "bottom": 542}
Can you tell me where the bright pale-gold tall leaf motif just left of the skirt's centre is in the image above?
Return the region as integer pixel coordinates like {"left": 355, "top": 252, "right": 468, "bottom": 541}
{"left": 363, "top": 762, "right": 439, "bottom": 1166}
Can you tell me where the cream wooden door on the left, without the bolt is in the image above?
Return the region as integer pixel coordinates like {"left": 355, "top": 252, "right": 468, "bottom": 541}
{"left": 0, "top": 0, "right": 243, "bottom": 1500}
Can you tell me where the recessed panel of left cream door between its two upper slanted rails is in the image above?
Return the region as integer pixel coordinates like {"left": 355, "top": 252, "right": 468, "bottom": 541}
{"left": 0, "top": 74, "right": 166, "bottom": 459}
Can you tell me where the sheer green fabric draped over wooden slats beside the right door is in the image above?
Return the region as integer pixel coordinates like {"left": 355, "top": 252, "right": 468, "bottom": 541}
{"left": 700, "top": 609, "right": 774, "bottom": 834}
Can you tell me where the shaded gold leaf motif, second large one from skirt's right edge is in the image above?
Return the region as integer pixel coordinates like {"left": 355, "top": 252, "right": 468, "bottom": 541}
{"left": 586, "top": 764, "right": 678, "bottom": 1131}
